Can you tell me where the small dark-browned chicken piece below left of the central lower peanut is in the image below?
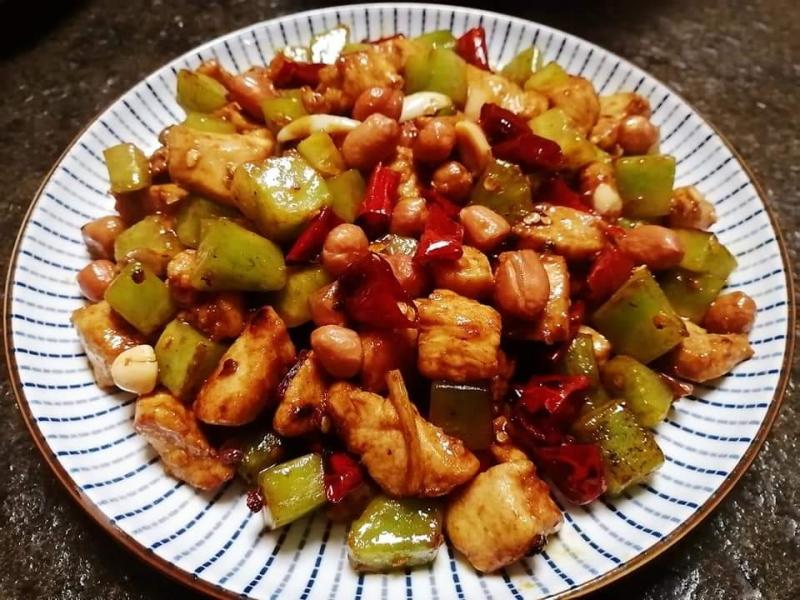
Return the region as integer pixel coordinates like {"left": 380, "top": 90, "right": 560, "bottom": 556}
{"left": 272, "top": 352, "right": 328, "bottom": 437}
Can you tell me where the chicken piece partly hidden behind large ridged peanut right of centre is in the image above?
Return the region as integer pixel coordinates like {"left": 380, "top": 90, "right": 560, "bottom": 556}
{"left": 509, "top": 254, "right": 569, "bottom": 344}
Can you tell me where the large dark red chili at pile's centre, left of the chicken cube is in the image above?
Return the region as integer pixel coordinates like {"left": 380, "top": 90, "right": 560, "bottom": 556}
{"left": 339, "top": 252, "right": 417, "bottom": 329}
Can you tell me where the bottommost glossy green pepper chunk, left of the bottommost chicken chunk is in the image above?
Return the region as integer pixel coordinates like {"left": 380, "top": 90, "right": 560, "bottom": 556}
{"left": 347, "top": 496, "right": 444, "bottom": 572}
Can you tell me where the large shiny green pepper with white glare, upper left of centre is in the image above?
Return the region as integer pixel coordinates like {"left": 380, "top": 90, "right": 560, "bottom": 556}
{"left": 233, "top": 155, "right": 331, "bottom": 243}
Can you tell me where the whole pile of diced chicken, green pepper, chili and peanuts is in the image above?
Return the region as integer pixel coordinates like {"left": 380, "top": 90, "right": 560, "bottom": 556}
{"left": 72, "top": 27, "right": 756, "bottom": 572}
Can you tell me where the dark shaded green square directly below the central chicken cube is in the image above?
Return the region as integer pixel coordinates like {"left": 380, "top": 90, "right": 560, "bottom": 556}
{"left": 429, "top": 381, "right": 494, "bottom": 450}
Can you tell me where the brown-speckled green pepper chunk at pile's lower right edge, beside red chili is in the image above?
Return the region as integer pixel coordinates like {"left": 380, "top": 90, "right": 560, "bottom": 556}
{"left": 572, "top": 402, "right": 664, "bottom": 496}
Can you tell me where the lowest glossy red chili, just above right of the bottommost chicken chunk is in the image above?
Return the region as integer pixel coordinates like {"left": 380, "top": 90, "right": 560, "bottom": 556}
{"left": 533, "top": 444, "right": 606, "bottom": 504}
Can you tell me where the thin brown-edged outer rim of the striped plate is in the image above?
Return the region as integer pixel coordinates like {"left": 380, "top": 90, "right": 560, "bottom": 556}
{"left": 3, "top": 2, "right": 797, "bottom": 600}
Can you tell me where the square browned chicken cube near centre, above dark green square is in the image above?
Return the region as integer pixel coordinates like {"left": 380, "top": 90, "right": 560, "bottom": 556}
{"left": 416, "top": 290, "right": 502, "bottom": 383}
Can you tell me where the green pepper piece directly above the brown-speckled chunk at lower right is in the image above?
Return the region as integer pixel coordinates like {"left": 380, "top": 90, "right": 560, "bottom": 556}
{"left": 600, "top": 354, "right": 673, "bottom": 427}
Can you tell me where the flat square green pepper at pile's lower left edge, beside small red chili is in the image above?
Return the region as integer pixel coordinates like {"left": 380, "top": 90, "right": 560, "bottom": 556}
{"left": 258, "top": 453, "right": 326, "bottom": 529}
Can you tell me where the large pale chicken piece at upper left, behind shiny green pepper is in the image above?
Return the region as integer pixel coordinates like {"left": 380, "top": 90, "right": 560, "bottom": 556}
{"left": 166, "top": 125, "right": 275, "bottom": 206}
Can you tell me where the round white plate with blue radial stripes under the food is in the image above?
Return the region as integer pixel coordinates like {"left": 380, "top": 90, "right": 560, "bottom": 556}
{"left": 6, "top": 4, "right": 794, "bottom": 599}
